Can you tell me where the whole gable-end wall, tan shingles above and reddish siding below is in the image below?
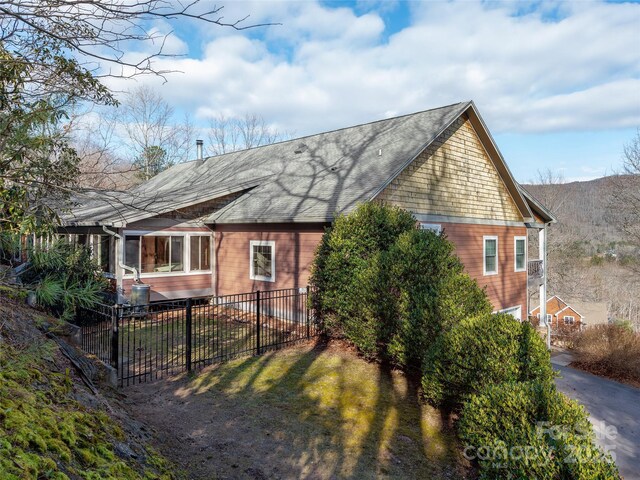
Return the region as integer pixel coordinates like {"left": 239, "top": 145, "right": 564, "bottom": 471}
{"left": 377, "top": 116, "right": 527, "bottom": 317}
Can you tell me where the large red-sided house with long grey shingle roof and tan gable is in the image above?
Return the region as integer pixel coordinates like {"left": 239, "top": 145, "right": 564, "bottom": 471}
{"left": 61, "top": 102, "right": 555, "bottom": 318}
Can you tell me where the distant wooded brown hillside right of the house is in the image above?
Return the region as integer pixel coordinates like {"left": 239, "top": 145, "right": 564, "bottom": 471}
{"left": 523, "top": 176, "right": 640, "bottom": 328}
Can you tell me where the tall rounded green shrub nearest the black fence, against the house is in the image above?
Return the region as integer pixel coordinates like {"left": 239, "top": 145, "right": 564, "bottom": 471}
{"left": 310, "top": 203, "right": 416, "bottom": 357}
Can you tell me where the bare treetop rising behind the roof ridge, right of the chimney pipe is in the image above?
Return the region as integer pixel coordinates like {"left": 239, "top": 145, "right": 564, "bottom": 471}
{"left": 209, "top": 114, "right": 291, "bottom": 155}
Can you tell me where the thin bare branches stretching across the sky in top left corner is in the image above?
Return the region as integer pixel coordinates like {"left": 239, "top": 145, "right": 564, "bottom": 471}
{"left": 0, "top": 0, "right": 258, "bottom": 96}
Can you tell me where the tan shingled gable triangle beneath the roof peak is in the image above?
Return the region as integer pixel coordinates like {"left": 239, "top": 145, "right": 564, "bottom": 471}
{"left": 377, "top": 117, "right": 523, "bottom": 222}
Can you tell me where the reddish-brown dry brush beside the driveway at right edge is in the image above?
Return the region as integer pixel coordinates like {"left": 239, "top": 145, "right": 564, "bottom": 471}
{"left": 573, "top": 325, "right": 640, "bottom": 386}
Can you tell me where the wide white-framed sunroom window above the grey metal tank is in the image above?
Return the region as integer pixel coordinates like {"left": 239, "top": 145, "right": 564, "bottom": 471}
{"left": 124, "top": 235, "right": 184, "bottom": 273}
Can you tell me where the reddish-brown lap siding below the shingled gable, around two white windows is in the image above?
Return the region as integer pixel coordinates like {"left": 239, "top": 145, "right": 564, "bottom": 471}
{"left": 442, "top": 223, "right": 527, "bottom": 318}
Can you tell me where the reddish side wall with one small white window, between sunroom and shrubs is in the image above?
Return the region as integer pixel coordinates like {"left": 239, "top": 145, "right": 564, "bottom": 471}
{"left": 214, "top": 224, "right": 325, "bottom": 295}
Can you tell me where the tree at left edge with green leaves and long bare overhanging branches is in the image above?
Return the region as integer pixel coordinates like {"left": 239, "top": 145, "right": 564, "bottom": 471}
{"left": 0, "top": 0, "right": 268, "bottom": 233}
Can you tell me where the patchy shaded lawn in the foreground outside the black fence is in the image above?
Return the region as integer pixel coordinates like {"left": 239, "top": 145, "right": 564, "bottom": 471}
{"left": 124, "top": 344, "right": 473, "bottom": 479}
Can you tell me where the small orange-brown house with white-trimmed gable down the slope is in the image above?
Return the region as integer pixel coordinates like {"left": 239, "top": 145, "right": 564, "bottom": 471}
{"left": 530, "top": 295, "right": 609, "bottom": 331}
